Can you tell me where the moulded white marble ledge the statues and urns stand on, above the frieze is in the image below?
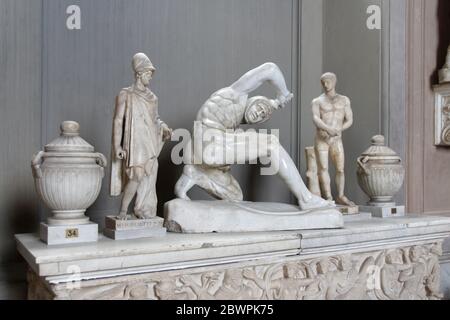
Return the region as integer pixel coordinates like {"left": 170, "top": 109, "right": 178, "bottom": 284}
{"left": 16, "top": 215, "right": 450, "bottom": 283}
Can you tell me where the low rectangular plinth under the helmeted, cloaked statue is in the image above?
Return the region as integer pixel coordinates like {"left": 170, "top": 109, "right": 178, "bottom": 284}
{"left": 103, "top": 216, "right": 166, "bottom": 240}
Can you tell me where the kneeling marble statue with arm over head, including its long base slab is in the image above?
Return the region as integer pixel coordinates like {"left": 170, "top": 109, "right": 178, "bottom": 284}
{"left": 164, "top": 63, "right": 344, "bottom": 233}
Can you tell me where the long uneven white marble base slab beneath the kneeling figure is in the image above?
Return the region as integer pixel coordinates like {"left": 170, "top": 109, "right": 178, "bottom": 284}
{"left": 164, "top": 199, "right": 344, "bottom": 233}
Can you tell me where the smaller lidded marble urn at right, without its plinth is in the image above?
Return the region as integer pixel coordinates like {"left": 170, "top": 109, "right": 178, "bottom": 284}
{"left": 357, "top": 135, "right": 405, "bottom": 206}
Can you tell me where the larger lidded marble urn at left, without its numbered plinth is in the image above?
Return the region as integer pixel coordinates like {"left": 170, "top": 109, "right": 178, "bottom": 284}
{"left": 32, "top": 121, "right": 107, "bottom": 226}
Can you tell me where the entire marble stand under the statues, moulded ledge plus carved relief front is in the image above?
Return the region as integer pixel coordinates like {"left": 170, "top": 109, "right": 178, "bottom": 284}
{"left": 16, "top": 215, "right": 450, "bottom": 300}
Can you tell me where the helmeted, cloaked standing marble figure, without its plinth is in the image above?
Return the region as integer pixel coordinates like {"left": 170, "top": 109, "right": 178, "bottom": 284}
{"left": 111, "top": 53, "right": 172, "bottom": 220}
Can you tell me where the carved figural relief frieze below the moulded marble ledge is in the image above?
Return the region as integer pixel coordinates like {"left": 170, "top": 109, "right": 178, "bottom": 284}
{"left": 29, "top": 243, "right": 442, "bottom": 300}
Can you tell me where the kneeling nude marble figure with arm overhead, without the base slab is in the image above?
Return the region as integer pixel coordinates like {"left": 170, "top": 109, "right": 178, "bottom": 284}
{"left": 175, "top": 63, "right": 330, "bottom": 210}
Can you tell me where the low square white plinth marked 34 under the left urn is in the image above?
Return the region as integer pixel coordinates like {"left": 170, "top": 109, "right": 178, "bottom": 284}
{"left": 40, "top": 222, "right": 98, "bottom": 246}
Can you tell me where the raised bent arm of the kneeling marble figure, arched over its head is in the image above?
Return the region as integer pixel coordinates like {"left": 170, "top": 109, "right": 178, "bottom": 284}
{"left": 231, "top": 62, "right": 293, "bottom": 106}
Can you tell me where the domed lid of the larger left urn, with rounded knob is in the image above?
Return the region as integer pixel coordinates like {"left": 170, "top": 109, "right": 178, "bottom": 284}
{"left": 45, "top": 121, "right": 94, "bottom": 153}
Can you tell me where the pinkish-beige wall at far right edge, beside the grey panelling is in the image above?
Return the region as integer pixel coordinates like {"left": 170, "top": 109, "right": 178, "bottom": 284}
{"left": 406, "top": 0, "right": 450, "bottom": 214}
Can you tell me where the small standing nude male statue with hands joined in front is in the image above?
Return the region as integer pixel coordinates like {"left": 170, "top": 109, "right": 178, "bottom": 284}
{"left": 312, "top": 73, "right": 355, "bottom": 206}
